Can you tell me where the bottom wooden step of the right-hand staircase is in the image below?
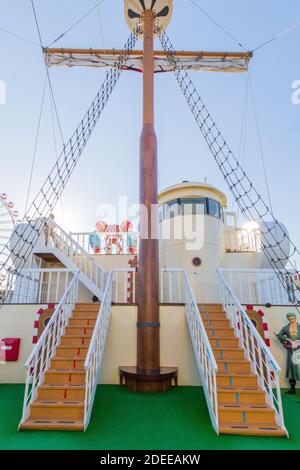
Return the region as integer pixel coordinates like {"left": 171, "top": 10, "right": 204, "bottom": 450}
{"left": 219, "top": 422, "right": 287, "bottom": 437}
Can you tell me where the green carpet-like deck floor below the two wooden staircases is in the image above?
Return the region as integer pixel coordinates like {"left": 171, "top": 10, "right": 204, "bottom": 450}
{"left": 0, "top": 385, "right": 300, "bottom": 450}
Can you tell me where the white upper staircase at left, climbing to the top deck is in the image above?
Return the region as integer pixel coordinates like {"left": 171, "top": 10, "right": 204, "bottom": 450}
{"left": 33, "top": 225, "right": 108, "bottom": 300}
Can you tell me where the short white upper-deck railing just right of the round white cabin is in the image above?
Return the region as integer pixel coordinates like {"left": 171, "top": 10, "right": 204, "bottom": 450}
{"left": 224, "top": 227, "right": 262, "bottom": 253}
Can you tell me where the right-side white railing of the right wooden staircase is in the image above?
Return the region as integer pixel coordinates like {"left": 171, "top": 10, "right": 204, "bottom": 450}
{"left": 217, "top": 270, "right": 286, "bottom": 430}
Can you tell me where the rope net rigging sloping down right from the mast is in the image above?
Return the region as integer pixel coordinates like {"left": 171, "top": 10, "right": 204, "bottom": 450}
{"left": 160, "top": 31, "right": 300, "bottom": 304}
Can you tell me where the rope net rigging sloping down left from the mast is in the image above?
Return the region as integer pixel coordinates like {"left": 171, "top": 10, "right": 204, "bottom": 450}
{"left": 0, "top": 25, "right": 139, "bottom": 306}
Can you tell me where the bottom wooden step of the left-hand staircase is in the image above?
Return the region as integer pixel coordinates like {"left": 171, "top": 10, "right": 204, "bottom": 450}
{"left": 20, "top": 418, "right": 84, "bottom": 431}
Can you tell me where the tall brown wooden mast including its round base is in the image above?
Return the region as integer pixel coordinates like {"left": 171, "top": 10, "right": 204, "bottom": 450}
{"left": 120, "top": 10, "right": 177, "bottom": 392}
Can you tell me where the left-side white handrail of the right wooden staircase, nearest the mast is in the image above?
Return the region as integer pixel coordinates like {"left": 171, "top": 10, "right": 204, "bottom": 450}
{"left": 182, "top": 270, "right": 219, "bottom": 433}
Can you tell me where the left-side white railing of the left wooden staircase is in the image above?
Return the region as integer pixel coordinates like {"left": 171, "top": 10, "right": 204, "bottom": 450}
{"left": 20, "top": 272, "right": 79, "bottom": 424}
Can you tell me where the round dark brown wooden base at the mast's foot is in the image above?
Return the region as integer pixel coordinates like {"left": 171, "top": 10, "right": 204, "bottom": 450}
{"left": 119, "top": 366, "right": 178, "bottom": 393}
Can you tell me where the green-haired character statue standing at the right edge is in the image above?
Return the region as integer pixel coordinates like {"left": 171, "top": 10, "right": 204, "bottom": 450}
{"left": 276, "top": 312, "right": 300, "bottom": 395}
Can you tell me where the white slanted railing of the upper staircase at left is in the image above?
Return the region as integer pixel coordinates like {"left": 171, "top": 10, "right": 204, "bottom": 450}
{"left": 42, "top": 225, "right": 108, "bottom": 294}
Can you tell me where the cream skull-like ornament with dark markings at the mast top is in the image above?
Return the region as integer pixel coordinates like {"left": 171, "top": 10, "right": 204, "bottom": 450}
{"left": 124, "top": 0, "right": 173, "bottom": 36}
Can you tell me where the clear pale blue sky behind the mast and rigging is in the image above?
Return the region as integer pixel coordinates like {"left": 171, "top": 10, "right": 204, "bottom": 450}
{"left": 0, "top": 0, "right": 300, "bottom": 246}
